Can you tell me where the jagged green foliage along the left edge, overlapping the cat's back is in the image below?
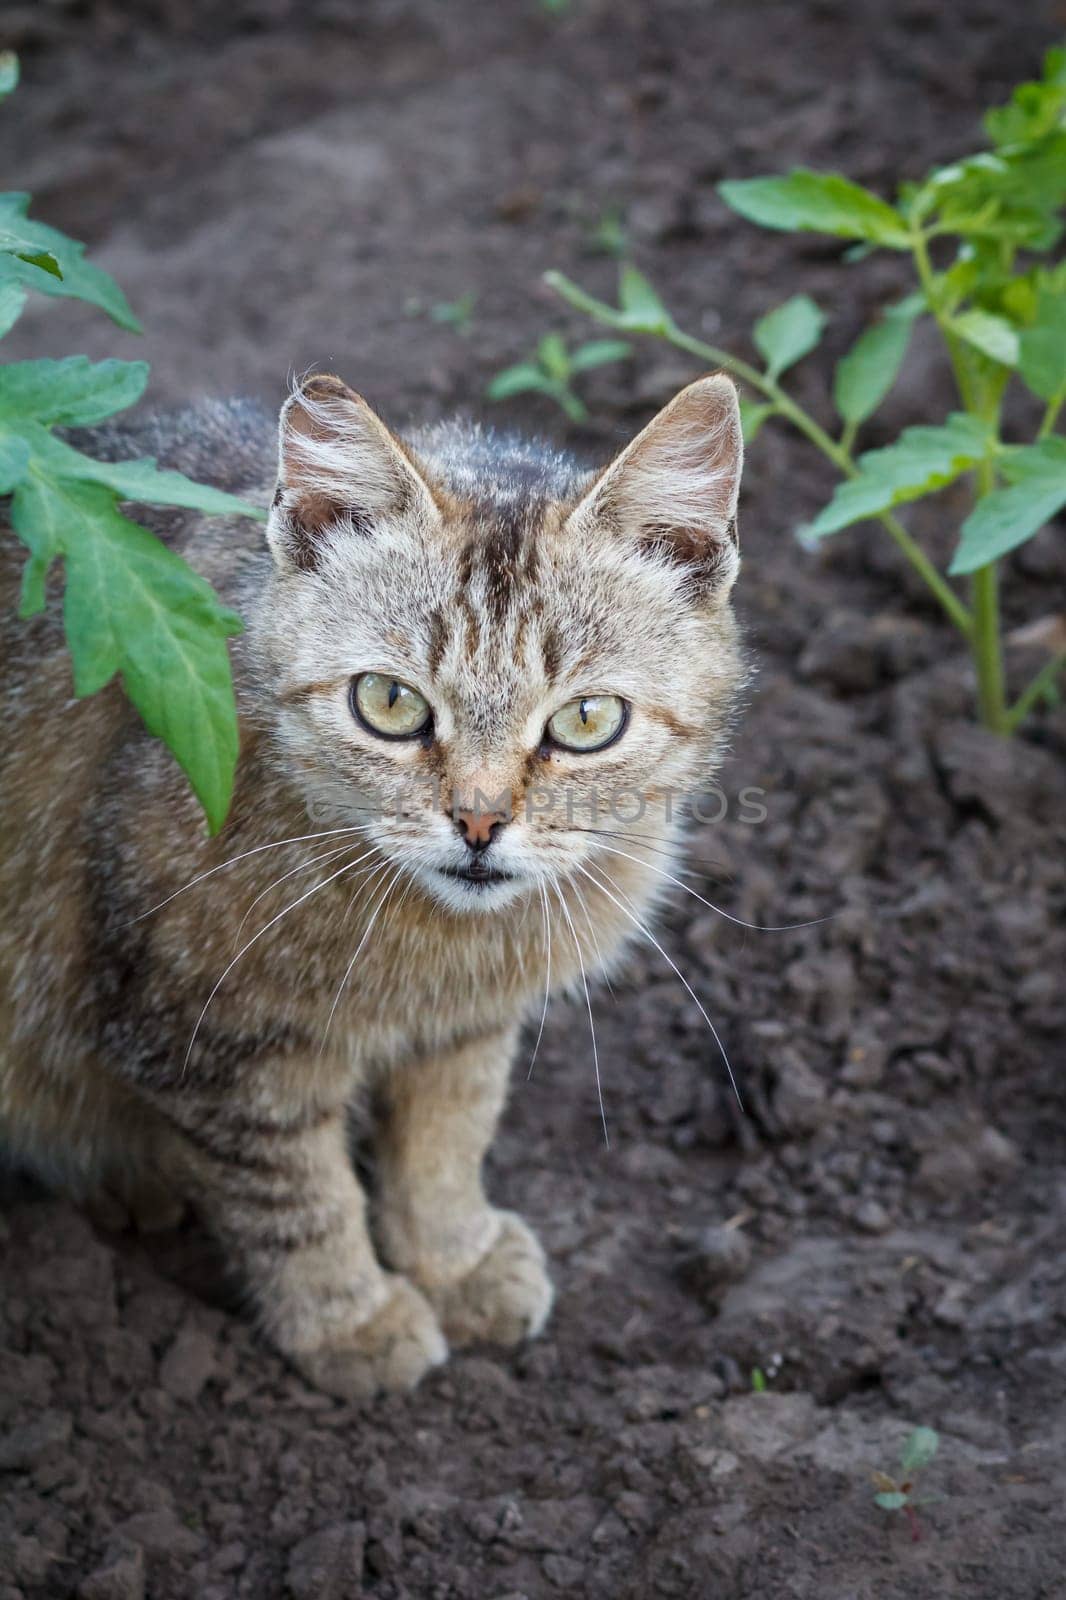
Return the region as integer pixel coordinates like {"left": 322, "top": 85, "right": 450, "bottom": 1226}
{"left": 0, "top": 58, "right": 262, "bottom": 832}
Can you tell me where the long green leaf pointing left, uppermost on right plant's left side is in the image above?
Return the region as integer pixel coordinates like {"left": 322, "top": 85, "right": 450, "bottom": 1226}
{"left": 719, "top": 166, "right": 911, "bottom": 250}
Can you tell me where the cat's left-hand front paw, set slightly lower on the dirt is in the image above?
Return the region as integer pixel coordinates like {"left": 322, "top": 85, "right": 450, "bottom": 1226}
{"left": 290, "top": 1277, "right": 448, "bottom": 1400}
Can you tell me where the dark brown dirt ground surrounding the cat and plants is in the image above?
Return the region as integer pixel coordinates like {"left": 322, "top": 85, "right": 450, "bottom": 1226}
{"left": 0, "top": 0, "right": 1066, "bottom": 1600}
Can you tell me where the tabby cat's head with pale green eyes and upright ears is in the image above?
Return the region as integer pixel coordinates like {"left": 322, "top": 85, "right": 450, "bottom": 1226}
{"left": 256, "top": 376, "right": 741, "bottom": 912}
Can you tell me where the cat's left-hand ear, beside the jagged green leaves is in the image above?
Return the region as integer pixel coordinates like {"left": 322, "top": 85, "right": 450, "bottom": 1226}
{"left": 267, "top": 374, "right": 435, "bottom": 571}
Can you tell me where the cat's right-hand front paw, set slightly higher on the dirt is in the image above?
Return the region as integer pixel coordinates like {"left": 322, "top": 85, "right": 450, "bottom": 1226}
{"left": 426, "top": 1211, "right": 554, "bottom": 1346}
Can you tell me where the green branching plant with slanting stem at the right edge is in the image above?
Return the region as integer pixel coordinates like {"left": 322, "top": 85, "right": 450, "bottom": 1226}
{"left": 546, "top": 50, "right": 1066, "bottom": 733}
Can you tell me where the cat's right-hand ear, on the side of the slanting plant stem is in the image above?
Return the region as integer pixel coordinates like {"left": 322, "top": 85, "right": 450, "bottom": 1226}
{"left": 570, "top": 373, "right": 744, "bottom": 597}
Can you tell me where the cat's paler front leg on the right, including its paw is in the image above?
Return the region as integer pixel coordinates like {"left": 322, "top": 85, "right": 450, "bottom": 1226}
{"left": 378, "top": 1029, "right": 552, "bottom": 1344}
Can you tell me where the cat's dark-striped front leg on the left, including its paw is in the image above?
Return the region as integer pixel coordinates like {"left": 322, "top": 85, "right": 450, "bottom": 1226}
{"left": 164, "top": 1099, "right": 448, "bottom": 1398}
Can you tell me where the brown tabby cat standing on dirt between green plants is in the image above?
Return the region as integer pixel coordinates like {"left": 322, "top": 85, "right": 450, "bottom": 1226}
{"left": 0, "top": 374, "right": 743, "bottom": 1398}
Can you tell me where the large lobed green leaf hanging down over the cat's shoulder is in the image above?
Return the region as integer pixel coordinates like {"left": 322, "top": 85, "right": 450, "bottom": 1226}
{"left": 14, "top": 477, "right": 240, "bottom": 832}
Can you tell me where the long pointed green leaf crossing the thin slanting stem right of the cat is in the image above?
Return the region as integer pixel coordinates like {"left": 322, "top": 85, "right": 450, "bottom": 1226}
{"left": 805, "top": 411, "right": 989, "bottom": 539}
